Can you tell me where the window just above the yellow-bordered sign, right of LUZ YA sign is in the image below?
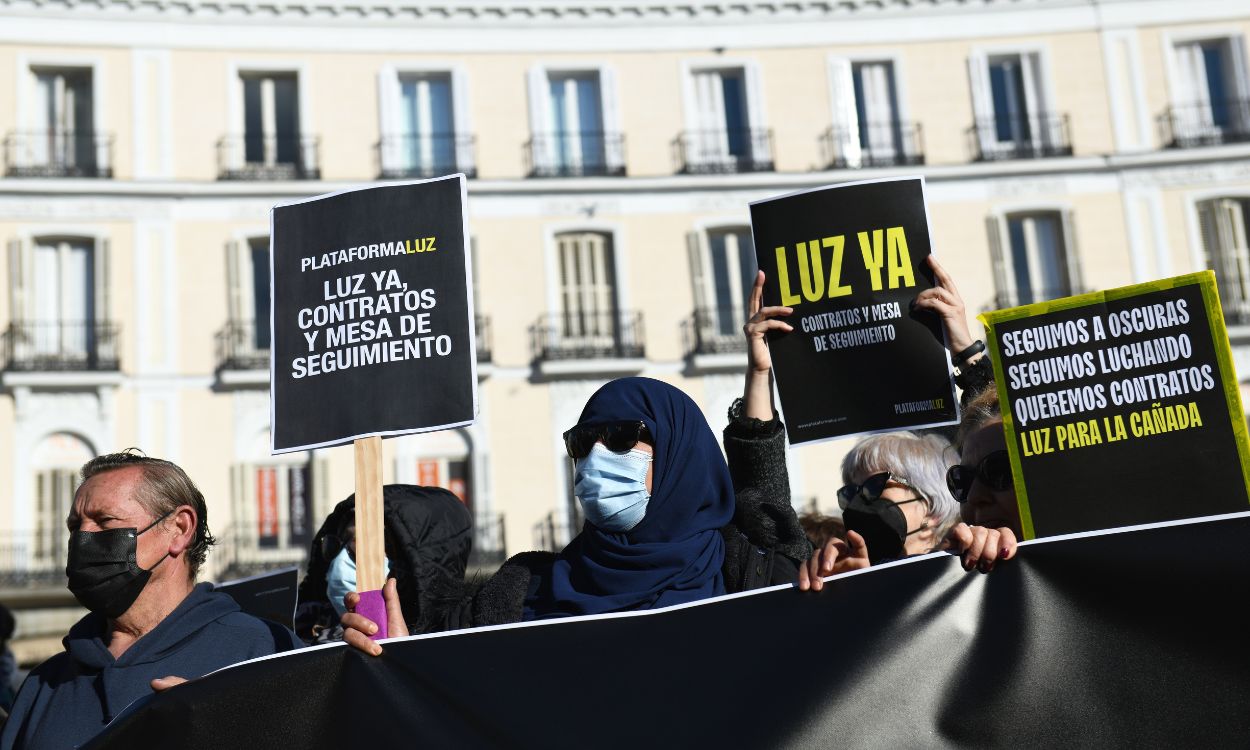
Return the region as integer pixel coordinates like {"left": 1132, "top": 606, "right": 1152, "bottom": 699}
{"left": 990, "top": 211, "right": 1080, "bottom": 308}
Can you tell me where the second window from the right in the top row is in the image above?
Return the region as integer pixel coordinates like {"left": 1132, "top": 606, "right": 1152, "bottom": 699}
{"left": 969, "top": 53, "right": 1071, "bottom": 160}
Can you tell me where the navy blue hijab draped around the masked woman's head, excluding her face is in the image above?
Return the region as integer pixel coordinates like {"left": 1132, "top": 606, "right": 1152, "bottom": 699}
{"left": 524, "top": 378, "right": 734, "bottom": 620}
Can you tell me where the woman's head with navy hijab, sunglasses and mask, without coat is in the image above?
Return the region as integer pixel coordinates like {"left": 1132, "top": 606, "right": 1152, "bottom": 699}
{"left": 525, "top": 378, "right": 734, "bottom": 619}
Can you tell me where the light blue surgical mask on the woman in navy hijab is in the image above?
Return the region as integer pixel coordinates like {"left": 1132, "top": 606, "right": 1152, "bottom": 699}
{"left": 573, "top": 443, "right": 651, "bottom": 531}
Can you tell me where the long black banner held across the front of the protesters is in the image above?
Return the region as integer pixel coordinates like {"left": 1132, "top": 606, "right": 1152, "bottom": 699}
{"left": 91, "top": 515, "right": 1250, "bottom": 750}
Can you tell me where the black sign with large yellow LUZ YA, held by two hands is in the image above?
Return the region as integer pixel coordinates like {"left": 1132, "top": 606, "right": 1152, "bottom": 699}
{"left": 751, "top": 178, "right": 959, "bottom": 443}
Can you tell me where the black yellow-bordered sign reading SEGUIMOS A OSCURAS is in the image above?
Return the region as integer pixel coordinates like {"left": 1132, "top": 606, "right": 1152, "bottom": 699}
{"left": 981, "top": 271, "right": 1250, "bottom": 539}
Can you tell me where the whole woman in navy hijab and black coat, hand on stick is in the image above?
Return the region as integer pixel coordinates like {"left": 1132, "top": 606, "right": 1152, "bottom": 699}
{"left": 343, "top": 378, "right": 811, "bottom": 654}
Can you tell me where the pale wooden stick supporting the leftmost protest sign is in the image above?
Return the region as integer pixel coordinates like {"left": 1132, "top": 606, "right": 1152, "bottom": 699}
{"left": 355, "top": 436, "right": 386, "bottom": 640}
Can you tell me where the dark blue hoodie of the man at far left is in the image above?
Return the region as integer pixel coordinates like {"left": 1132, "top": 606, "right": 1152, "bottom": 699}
{"left": 0, "top": 584, "right": 296, "bottom": 750}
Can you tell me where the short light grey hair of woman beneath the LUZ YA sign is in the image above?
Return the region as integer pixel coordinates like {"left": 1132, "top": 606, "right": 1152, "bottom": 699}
{"left": 843, "top": 433, "right": 959, "bottom": 544}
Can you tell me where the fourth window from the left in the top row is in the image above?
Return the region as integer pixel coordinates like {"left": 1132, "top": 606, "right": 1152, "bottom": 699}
{"left": 530, "top": 69, "right": 625, "bottom": 176}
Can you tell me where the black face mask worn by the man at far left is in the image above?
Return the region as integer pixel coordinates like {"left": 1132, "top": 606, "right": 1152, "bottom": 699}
{"left": 65, "top": 511, "right": 173, "bottom": 620}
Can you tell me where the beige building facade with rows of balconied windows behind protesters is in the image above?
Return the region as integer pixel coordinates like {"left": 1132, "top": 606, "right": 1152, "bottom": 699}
{"left": 0, "top": 0, "right": 1250, "bottom": 655}
